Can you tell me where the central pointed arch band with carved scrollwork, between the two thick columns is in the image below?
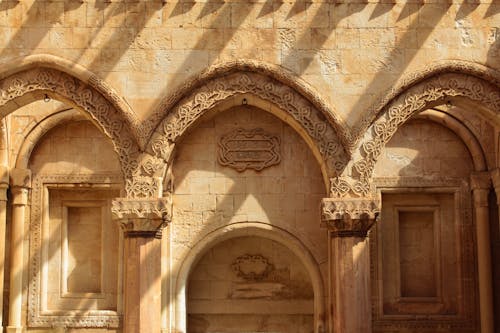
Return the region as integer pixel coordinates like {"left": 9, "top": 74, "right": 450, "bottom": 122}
{"left": 143, "top": 63, "right": 349, "bottom": 177}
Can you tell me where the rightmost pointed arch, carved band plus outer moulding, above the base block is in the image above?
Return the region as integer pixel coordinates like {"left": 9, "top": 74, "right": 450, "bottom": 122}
{"left": 351, "top": 61, "right": 500, "bottom": 196}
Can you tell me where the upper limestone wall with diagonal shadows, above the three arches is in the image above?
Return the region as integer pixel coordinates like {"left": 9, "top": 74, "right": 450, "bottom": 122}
{"left": 0, "top": 0, "right": 494, "bottom": 125}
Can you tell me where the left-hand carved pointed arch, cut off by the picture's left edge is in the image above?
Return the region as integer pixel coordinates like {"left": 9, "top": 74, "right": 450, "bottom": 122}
{"left": 0, "top": 57, "right": 140, "bottom": 192}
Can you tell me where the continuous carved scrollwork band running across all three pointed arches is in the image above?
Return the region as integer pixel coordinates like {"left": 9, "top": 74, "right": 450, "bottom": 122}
{"left": 0, "top": 63, "right": 500, "bottom": 198}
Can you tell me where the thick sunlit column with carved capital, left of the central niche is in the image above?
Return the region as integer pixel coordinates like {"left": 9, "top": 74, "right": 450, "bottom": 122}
{"left": 112, "top": 198, "right": 171, "bottom": 333}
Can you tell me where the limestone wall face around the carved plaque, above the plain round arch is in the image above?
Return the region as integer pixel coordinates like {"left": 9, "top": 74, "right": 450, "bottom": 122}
{"left": 169, "top": 106, "right": 328, "bottom": 329}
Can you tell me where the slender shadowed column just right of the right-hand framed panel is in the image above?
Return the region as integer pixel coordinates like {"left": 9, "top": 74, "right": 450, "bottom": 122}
{"left": 471, "top": 172, "right": 495, "bottom": 333}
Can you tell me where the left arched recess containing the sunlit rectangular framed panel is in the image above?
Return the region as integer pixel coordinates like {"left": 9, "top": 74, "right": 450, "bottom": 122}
{"left": 28, "top": 121, "right": 123, "bottom": 327}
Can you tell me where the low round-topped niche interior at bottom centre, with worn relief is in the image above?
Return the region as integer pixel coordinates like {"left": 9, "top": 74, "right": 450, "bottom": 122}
{"left": 187, "top": 236, "right": 314, "bottom": 333}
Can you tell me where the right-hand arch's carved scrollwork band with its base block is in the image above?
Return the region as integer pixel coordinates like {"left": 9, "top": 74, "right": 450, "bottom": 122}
{"left": 340, "top": 71, "right": 500, "bottom": 196}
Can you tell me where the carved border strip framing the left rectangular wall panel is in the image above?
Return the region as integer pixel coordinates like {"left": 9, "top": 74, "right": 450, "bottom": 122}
{"left": 28, "top": 174, "right": 123, "bottom": 328}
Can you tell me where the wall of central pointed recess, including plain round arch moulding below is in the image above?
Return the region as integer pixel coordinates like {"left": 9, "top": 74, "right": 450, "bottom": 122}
{"left": 163, "top": 105, "right": 328, "bottom": 332}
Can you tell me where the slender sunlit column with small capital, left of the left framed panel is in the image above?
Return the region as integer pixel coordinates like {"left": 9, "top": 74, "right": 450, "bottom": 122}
{"left": 7, "top": 169, "right": 31, "bottom": 333}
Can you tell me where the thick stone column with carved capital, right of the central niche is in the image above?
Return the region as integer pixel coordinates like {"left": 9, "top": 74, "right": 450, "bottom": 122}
{"left": 322, "top": 198, "right": 380, "bottom": 333}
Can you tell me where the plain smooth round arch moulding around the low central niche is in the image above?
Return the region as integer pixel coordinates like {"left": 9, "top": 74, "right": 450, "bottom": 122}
{"left": 174, "top": 222, "right": 327, "bottom": 333}
